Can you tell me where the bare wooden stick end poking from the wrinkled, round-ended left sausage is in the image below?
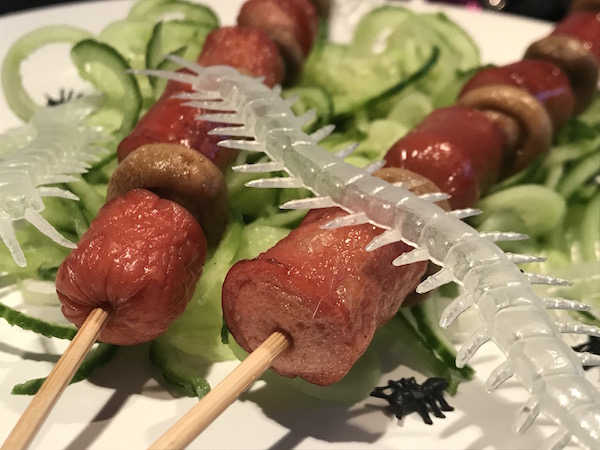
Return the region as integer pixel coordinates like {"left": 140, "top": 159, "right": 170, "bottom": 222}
{"left": 2, "top": 308, "right": 109, "bottom": 450}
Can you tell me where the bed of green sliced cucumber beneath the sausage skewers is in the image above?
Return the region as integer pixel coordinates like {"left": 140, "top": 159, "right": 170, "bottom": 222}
{"left": 0, "top": 0, "right": 600, "bottom": 446}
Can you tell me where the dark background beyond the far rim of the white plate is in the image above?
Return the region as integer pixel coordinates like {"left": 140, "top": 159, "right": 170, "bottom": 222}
{"left": 0, "top": 0, "right": 570, "bottom": 21}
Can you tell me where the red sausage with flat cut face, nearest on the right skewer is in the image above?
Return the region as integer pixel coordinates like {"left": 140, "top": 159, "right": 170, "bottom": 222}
{"left": 223, "top": 208, "right": 427, "bottom": 385}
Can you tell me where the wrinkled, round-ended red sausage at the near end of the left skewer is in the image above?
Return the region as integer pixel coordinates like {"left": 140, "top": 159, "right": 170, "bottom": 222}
{"left": 56, "top": 189, "right": 206, "bottom": 345}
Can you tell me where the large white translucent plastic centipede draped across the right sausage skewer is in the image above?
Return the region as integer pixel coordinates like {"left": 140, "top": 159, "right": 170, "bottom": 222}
{"left": 144, "top": 58, "right": 600, "bottom": 449}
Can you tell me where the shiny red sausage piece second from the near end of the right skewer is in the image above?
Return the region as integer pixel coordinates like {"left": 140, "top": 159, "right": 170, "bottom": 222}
{"left": 385, "top": 106, "right": 504, "bottom": 208}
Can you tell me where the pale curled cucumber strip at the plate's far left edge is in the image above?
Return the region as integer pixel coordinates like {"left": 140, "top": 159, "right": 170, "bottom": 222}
{"left": 1, "top": 25, "right": 91, "bottom": 121}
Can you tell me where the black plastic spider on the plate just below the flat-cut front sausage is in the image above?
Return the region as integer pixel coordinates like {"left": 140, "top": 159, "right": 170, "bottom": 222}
{"left": 370, "top": 377, "right": 454, "bottom": 425}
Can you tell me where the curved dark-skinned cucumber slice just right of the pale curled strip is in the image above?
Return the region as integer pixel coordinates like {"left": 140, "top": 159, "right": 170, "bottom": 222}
{"left": 71, "top": 39, "right": 142, "bottom": 138}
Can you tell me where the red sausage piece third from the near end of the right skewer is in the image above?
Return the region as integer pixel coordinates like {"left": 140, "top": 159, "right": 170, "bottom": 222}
{"left": 459, "top": 59, "right": 575, "bottom": 131}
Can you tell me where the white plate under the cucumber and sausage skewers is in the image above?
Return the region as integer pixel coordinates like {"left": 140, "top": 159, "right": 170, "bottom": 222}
{"left": 0, "top": 0, "right": 597, "bottom": 449}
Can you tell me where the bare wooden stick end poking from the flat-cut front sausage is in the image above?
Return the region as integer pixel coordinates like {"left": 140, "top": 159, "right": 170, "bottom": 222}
{"left": 149, "top": 332, "right": 291, "bottom": 450}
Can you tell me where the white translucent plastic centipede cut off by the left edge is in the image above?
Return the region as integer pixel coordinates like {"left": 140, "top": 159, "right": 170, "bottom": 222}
{"left": 0, "top": 97, "right": 107, "bottom": 267}
